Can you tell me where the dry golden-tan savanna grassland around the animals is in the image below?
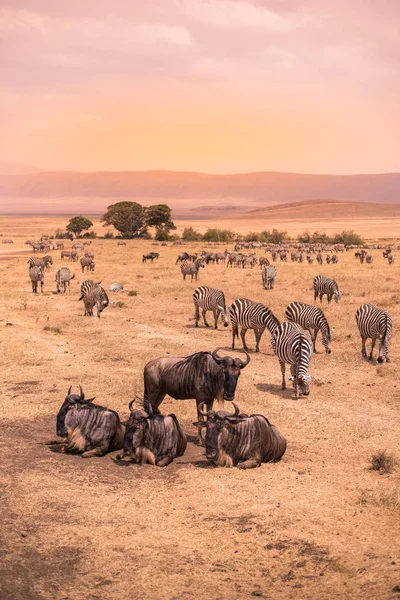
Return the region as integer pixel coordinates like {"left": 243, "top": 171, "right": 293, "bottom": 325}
{"left": 0, "top": 217, "right": 400, "bottom": 600}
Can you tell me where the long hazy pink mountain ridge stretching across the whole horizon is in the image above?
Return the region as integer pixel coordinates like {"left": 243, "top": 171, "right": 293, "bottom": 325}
{"left": 0, "top": 165, "right": 400, "bottom": 218}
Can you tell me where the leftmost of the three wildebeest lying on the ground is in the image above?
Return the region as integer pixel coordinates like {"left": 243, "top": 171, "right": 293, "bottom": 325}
{"left": 46, "top": 386, "right": 125, "bottom": 458}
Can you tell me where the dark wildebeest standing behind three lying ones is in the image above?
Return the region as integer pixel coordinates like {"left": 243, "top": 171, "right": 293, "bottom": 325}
{"left": 144, "top": 348, "right": 250, "bottom": 443}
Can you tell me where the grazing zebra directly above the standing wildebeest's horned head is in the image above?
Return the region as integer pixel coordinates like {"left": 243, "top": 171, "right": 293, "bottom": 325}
{"left": 229, "top": 298, "right": 279, "bottom": 352}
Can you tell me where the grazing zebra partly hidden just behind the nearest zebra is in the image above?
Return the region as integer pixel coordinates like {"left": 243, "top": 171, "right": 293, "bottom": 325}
{"left": 285, "top": 302, "right": 332, "bottom": 354}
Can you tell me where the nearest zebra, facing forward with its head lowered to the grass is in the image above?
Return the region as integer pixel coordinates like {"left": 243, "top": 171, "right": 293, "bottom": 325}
{"left": 271, "top": 321, "right": 312, "bottom": 400}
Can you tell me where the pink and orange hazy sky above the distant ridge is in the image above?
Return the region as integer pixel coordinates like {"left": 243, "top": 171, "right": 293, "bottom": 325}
{"left": 0, "top": 0, "right": 400, "bottom": 173}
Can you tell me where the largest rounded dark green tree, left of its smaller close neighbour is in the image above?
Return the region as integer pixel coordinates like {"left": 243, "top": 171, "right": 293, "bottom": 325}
{"left": 101, "top": 201, "right": 146, "bottom": 238}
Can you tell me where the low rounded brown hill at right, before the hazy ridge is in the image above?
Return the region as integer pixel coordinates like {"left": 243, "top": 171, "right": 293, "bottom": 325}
{"left": 228, "top": 200, "right": 400, "bottom": 221}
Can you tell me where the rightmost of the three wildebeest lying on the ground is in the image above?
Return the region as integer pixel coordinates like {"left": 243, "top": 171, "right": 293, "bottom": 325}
{"left": 194, "top": 403, "right": 286, "bottom": 469}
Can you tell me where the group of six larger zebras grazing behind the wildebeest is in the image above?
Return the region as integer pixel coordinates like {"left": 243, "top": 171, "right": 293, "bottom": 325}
{"left": 193, "top": 275, "right": 392, "bottom": 400}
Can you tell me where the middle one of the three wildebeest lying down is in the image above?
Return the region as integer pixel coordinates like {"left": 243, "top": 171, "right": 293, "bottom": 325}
{"left": 116, "top": 400, "right": 186, "bottom": 467}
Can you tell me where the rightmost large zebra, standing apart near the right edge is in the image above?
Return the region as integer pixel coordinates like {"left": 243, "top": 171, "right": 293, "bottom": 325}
{"left": 356, "top": 304, "right": 392, "bottom": 363}
